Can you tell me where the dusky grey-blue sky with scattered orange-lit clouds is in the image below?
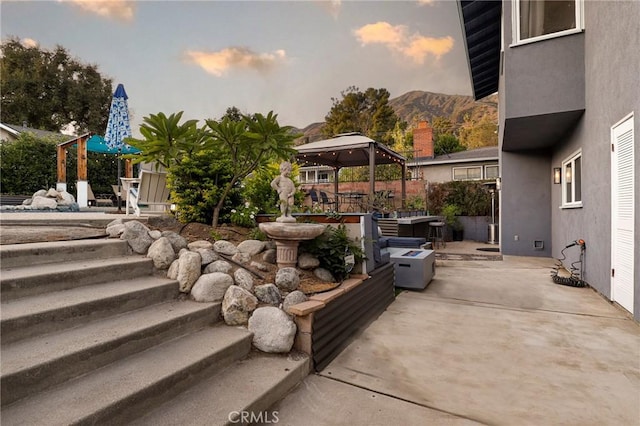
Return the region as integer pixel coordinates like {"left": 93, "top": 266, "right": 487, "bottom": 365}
{"left": 0, "top": 0, "right": 471, "bottom": 136}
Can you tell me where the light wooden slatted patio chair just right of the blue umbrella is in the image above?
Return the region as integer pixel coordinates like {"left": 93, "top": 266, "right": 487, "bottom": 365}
{"left": 126, "top": 170, "right": 171, "bottom": 216}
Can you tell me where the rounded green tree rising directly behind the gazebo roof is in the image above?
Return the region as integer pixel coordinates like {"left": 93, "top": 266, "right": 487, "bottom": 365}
{"left": 322, "top": 86, "right": 400, "bottom": 144}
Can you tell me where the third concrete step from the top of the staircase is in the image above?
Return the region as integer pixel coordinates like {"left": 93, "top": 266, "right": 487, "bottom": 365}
{"left": 0, "top": 276, "right": 179, "bottom": 345}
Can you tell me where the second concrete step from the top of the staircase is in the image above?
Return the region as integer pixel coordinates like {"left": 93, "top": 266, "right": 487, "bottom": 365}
{"left": 0, "top": 256, "right": 153, "bottom": 301}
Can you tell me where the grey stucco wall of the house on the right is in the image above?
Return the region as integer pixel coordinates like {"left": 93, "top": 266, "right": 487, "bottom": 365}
{"left": 499, "top": 1, "right": 640, "bottom": 320}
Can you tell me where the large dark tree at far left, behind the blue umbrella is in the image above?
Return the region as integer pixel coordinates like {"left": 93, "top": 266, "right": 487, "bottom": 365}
{"left": 0, "top": 37, "right": 112, "bottom": 134}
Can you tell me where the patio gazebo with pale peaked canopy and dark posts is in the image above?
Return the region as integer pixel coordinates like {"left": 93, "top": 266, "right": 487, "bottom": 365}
{"left": 296, "top": 132, "right": 407, "bottom": 211}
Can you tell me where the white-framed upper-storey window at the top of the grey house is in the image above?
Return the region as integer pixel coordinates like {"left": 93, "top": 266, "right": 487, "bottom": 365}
{"left": 513, "top": 0, "right": 582, "bottom": 44}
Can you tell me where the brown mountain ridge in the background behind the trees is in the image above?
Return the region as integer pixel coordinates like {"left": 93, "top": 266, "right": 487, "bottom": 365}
{"left": 297, "top": 90, "right": 498, "bottom": 143}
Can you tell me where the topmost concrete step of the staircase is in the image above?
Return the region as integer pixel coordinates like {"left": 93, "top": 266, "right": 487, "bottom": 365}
{"left": 0, "top": 238, "right": 131, "bottom": 270}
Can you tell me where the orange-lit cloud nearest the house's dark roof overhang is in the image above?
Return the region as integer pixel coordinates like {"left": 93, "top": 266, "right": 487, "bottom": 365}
{"left": 353, "top": 22, "right": 454, "bottom": 64}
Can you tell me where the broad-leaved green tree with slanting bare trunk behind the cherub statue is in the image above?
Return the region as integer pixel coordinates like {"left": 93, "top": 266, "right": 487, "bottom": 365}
{"left": 205, "top": 111, "right": 300, "bottom": 226}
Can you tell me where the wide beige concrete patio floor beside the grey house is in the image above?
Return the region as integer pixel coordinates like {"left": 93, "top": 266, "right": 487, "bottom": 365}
{"left": 272, "top": 253, "right": 640, "bottom": 425}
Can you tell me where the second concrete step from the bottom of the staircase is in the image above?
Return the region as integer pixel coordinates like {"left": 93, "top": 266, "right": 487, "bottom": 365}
{"left": 2, "top": 325, "right": 252, "bottom": 426}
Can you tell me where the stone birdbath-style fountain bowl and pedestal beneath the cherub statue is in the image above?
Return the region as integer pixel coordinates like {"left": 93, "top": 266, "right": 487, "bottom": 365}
{"left": 258, "top": 219, "right": 325, "bottom": 268}
